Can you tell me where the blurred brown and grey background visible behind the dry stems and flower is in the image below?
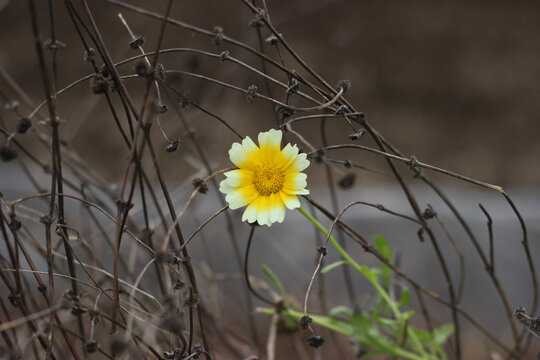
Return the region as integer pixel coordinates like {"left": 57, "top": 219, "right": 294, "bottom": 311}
{"left": 0, "top": 0, "right": 540, "bottom": 359}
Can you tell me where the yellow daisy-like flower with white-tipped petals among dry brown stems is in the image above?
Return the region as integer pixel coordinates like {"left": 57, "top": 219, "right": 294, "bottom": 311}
{"left": 219, "top": 129, "right": 309, "bottom": 226}
